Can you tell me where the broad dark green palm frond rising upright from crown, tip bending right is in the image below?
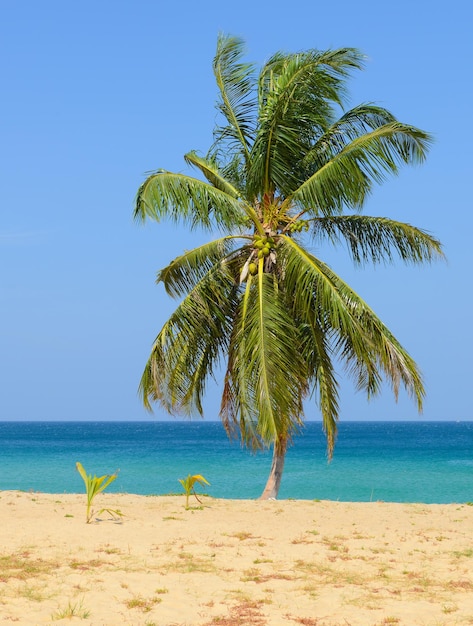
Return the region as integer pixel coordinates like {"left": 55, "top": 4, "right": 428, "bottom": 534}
{"left": 250, "top": 48, "right": 361, "bottom": 195}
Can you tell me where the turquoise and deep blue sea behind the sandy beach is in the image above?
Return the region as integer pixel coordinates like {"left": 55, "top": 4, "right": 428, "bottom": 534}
{"left": 0, "top": 421, "right": 473, "bottom": 504}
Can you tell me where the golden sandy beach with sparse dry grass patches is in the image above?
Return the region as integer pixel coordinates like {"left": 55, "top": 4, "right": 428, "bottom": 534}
{"left": 0, "top": 491, "right": 473, "bottom": 626}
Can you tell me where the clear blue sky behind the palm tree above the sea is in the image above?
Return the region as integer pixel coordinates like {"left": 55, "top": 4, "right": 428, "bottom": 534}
{"left": 0, "top": 0, "right": 473, "bottom": 420}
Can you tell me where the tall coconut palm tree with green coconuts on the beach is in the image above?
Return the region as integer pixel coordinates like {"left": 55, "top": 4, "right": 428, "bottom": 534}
{"left": 135, "top": 36, "right": 442, "bottom": 498}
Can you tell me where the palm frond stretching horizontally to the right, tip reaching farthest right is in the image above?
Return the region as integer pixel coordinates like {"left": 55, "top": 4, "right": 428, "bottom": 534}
{"left": 310, "top": 215, "right": 444, "bottom": 264}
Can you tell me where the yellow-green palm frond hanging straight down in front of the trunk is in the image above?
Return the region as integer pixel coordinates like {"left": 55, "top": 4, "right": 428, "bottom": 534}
{"left": 222, "top": 262, "right": 307, "bottom": 445}
